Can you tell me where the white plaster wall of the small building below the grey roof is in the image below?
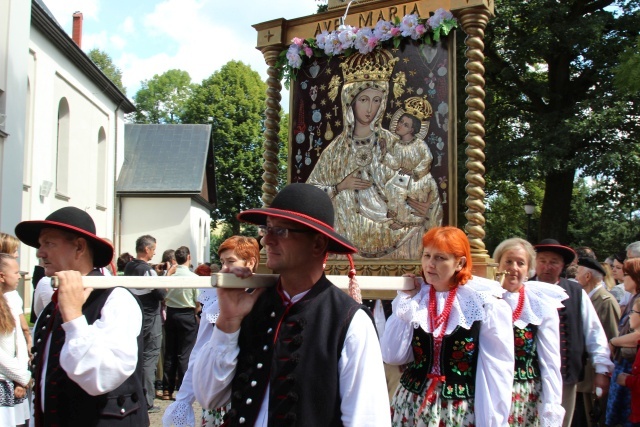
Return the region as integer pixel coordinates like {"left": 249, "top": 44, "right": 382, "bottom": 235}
{"left": 117, "top": 197, "right": 211, "bottom": 267}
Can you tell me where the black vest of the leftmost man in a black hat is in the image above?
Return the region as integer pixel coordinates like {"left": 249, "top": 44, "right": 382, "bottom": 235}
{"left": 31, "top": 270, "right": 149, "bottom": 427}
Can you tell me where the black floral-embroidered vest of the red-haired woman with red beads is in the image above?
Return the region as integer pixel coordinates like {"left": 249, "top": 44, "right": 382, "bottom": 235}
{"left": 400, "top": 321, "right": 480, "bottom": 399}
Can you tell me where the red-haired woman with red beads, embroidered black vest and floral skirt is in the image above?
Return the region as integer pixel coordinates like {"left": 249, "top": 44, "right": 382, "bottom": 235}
{"left": 381, "top": 227, "right": 514, "bottom": 427}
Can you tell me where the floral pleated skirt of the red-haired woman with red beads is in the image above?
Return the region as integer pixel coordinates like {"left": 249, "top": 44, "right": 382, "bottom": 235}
{"left": 391, "top": 384, "right": 475, "bottom": 427}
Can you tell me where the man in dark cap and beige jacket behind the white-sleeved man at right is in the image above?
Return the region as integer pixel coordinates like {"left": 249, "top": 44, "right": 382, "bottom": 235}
{"left": 574, "top": 257, "right": 620, "bottom": 426}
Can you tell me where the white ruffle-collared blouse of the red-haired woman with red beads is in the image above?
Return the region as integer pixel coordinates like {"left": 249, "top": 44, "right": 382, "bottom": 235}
{"left": 380, "top": 283, "right": 514, "bottom": 427}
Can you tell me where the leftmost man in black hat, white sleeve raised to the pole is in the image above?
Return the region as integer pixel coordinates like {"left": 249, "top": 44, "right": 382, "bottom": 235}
{"left": 16, "top": 207, "right": 149, "bottom": 427}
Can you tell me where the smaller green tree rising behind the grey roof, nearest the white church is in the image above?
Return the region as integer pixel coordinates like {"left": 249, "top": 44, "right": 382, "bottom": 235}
{"left": 133, "top": 70, "right": 194, "bottom": 124}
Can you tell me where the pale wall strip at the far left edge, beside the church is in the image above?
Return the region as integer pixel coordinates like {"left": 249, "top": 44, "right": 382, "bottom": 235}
{"left": 0, "top": 0, "right": 31, "bottom": 234}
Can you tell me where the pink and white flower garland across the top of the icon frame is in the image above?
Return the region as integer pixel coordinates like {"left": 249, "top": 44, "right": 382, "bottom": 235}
{"left": 276, "top": 8, "right": 458, "bottom": 88}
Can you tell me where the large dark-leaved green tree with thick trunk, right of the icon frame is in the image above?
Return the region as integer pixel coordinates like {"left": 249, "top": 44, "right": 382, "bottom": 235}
{"left": 485, "top": 0, "right": 640, "bottom": 241}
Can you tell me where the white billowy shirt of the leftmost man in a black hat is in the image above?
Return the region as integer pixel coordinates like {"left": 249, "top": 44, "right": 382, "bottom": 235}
{"left": 40, "top": 288, "right": 142, "bottom": 408}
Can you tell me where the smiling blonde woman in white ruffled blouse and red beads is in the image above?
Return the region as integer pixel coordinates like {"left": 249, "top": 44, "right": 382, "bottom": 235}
{"left": 493, "top": 238, "right": 568, "bottom": 427}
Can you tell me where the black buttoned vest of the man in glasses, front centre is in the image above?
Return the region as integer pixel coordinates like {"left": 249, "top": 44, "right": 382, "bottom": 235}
{"left": 227, "top": 275, "right": 370, "bottom": 427}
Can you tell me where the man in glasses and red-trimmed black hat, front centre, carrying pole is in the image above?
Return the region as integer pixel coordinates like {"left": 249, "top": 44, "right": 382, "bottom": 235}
{"left": 193, "top": 184, "right": 391, "bottom": 426}
